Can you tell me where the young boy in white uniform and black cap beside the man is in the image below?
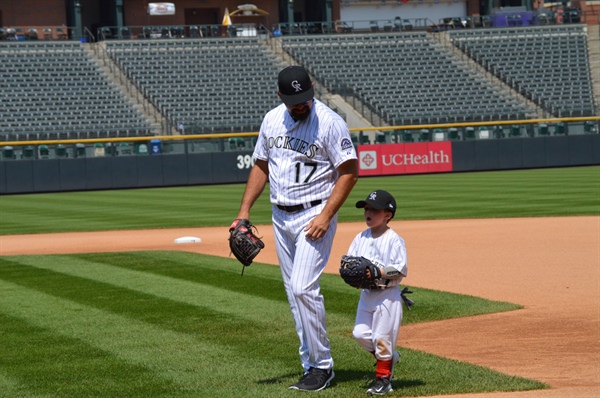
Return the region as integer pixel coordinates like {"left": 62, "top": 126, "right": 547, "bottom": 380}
{"left": 348, "top": 190, "right": 407, "bottom": 395}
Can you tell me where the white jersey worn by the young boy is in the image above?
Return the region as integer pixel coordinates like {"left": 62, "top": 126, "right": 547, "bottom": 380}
{"left": 348, "top": 228, "right": 408, "bottom": 287}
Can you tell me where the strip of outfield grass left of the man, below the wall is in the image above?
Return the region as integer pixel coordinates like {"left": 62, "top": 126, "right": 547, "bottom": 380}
{"left": 0, "top": 185, "right": 243, "bottom": 234}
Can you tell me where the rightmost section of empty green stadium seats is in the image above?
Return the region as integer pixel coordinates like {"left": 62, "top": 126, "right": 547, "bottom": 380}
{"left": 450, "top": 25, "right": 596, "bottom": 117}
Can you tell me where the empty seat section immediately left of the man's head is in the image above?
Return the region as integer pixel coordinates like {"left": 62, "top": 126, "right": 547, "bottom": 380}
{"left": 104, "top": 37, "right": 282, "bottom": 134}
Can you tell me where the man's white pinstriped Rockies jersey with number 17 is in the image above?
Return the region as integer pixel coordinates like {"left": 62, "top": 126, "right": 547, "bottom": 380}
{"left": 254, "top": 99, "right": 357, "bottom": 206}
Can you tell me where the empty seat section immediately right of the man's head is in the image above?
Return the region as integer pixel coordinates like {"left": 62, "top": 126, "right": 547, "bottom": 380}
{"left": 281, "top": 32, "right": 535, "bottom": 125}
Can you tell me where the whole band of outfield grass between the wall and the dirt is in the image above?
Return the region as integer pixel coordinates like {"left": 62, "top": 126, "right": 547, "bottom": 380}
{"left": 0, "top": 167, "right": 600, "bottom": 235}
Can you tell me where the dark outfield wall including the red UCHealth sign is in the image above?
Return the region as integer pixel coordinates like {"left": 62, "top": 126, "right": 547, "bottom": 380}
{"left": 0, "top": 134, "right": 600, "bottom": 194}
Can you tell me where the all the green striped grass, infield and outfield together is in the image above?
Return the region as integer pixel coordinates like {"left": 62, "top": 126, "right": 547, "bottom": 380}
{"left": 0, "top": 167, "right": 600, "bottom": 398}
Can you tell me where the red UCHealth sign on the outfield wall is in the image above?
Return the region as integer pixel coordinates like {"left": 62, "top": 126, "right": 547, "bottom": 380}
{"left": 357, "top": 141, "right": 452, "bottom": 176}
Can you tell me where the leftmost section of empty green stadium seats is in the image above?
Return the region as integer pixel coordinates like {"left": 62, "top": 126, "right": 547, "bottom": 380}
{"left": 0, "top": 40, "right": 152, "bottom": 140}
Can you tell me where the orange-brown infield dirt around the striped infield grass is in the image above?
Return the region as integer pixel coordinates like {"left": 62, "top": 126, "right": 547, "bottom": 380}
{"left": 0, "top": 217, "right": 600, "bottom": 398}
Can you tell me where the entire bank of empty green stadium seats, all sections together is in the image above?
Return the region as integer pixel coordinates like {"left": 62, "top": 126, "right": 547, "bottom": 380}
{"left": 0, "top": 27, "right": 598, "bottom": 143}
